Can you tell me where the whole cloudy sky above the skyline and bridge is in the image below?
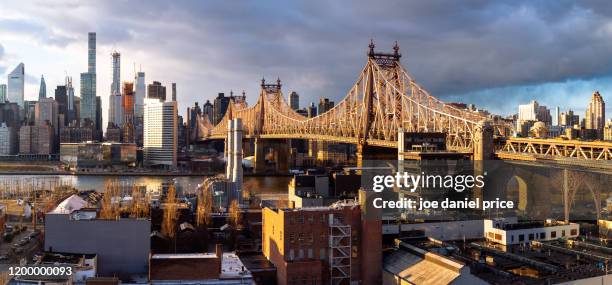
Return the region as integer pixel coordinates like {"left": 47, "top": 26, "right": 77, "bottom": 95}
{"left": 0, "top": 0, "right": 612, "bottom": 126}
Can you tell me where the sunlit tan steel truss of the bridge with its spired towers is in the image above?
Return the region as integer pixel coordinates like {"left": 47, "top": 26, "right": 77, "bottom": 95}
{"left": 194, "top": 43, "right": 513, "bottom": 152}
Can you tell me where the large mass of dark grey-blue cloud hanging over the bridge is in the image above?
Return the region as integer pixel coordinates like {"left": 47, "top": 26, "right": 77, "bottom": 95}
{"left": 0, "top": 0, "right": 612, "bottom": 112}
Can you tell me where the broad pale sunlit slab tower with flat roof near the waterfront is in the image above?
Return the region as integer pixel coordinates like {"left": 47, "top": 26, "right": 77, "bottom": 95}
{"left": 143, "top": 98, "right": 178, "bottom": 168}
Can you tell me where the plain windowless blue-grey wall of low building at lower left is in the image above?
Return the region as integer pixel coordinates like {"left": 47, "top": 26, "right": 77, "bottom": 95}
{"left": 45, "top": 214, "right": 151, "bottom": 275}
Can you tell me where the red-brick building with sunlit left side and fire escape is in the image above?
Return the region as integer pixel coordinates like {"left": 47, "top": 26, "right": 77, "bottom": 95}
{"left": 262, "top": 196, "right": 382, "bottom": 285}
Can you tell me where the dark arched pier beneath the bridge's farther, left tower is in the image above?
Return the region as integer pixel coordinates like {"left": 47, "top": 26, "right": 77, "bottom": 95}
{"left": 253, "top": 138, "right": 289, "bottom": 173}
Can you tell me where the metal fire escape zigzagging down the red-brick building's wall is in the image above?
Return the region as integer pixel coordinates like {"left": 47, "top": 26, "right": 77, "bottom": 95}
{"left": 329, "top": 214, "right": 351, "bottom": 285}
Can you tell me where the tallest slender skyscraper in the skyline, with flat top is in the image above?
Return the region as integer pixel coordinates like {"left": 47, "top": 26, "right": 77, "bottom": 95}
{"left": 79, "top": 33, "right": 101, "bottom": 127}
